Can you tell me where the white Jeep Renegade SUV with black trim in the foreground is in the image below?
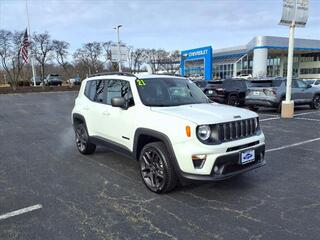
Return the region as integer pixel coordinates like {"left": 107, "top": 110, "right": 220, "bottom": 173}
{"left": 72, "top": 73, "right": 265, "bottom": 193}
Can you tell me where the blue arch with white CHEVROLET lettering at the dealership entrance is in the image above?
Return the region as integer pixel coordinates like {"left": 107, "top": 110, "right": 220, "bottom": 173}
{"left": 180, "top": 46, "right": 212, "bottom": 80}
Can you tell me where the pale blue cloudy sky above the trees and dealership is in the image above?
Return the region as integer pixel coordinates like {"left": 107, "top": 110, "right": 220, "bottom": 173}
{"left": 0, "top": 0, "right": 320, "bottom": 51}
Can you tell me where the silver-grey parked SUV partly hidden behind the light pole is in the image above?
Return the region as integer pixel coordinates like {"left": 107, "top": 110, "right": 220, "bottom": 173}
{"left": 246, "top": 79, "right": 320, "bottom": 112}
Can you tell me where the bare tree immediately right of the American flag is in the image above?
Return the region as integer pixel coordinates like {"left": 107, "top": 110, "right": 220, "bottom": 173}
{"left": 31, "top": 32, "right": 53, "bottom": 81}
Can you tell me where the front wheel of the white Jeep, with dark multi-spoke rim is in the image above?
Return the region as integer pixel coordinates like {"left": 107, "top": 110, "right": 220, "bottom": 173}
{"left": 139, "top": 142, "right": 177, "bottom": 193}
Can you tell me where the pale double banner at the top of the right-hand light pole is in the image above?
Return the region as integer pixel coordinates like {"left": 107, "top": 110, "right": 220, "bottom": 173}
{"left": 280, "top": 0, "right": 309, "bottom": 27}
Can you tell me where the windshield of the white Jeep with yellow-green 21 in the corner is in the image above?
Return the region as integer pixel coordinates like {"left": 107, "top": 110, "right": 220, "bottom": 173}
{"left": 136, "top": 78, "right": 211, "bottom": 107}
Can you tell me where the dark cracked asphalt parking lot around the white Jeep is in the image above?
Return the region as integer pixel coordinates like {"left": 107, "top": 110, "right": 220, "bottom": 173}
{"left": 0, "top": 92, "right": 320, "bottom": 240}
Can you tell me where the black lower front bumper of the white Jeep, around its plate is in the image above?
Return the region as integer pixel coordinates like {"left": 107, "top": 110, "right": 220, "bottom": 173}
{"left": 180, "top": 144, "right": 266, "bottom": 181}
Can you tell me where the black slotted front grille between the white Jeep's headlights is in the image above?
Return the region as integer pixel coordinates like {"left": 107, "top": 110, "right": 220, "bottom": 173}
{"left": 218, "top": 118, "right": 259, "bottom": 142}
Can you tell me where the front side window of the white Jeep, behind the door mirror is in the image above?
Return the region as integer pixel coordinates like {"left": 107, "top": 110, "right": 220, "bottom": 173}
{"left": 106, "top": 80, "right": 134, "bottom": 106}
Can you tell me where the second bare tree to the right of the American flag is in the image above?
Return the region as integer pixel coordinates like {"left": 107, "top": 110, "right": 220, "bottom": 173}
{"left": 52, "top": 40, "right": 70, "bottom": 78}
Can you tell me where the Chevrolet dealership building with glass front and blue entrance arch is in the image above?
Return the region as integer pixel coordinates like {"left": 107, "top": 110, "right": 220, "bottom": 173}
{"left": 181, "top": 36, "right": 320, "bottom": 80}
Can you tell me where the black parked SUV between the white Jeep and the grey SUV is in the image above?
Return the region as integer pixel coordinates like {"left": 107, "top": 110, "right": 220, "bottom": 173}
{"left": 204, "top": 79, "right": 249, "bottom": 106}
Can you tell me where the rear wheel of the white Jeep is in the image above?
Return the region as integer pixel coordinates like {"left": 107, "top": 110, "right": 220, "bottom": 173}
{"left": 74, "top": 123, "right": 96, "bottom": 155}
